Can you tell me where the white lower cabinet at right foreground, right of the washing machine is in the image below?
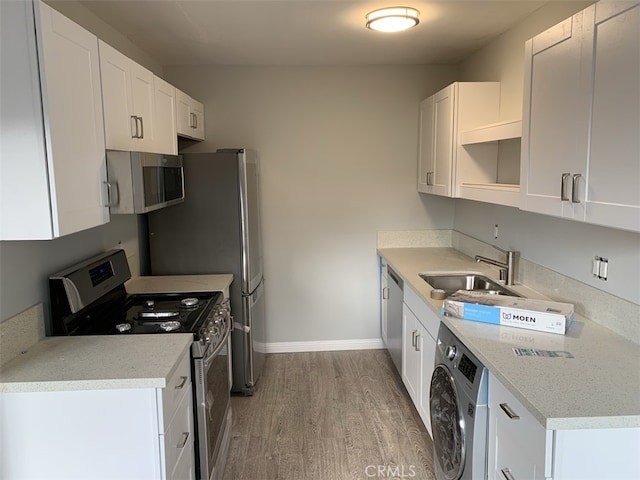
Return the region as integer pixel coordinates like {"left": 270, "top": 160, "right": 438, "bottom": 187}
{"left": 487, "top": 373, "right": 640, "bottom": 480}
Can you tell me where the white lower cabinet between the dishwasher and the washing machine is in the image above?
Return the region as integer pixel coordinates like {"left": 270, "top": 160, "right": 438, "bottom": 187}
{"left": 402, "top": 288, "right": 440, "bottom": 435}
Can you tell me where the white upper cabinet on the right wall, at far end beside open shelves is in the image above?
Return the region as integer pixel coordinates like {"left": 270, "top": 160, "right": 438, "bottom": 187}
{"left": 418, "top": 82, "right": 500, "bottom": 197}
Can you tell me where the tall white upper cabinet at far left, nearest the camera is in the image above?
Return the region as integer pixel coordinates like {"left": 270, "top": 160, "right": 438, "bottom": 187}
{"left": 0, "top": 2, "right": 109, "bottom": 240}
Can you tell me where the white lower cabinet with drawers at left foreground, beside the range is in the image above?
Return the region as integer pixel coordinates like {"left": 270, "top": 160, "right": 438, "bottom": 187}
{"left": 0, "top": 351, "right": 195, "bottom": 480}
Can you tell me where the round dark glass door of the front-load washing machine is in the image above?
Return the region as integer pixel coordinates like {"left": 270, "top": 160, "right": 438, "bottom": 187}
{"left": 429, "top": 365, "right": 465, "bottom": 480}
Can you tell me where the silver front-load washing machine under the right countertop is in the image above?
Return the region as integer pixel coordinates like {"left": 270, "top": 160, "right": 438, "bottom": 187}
{"left": 429, "top": 323, "right": 488, "bottom": 480}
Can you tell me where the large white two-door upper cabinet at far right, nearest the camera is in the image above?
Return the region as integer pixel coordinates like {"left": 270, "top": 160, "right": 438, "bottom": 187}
{"left": 521, "top": 2, "right": 640, "bottom": 231}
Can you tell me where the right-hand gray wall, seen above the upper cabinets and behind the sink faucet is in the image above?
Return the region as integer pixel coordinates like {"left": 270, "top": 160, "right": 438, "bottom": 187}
{"left": 454, "top": 1, "right": 640, "bottom": 306}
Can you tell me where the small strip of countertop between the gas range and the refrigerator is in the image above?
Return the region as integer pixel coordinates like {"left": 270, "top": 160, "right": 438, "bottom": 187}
{"left": 124, "top": 274, "right": 233, "bottom": 294}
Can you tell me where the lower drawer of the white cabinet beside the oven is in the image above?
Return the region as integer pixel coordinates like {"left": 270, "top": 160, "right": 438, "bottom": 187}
{"left": 160, "top": 384, "right": 194, "bottom": 479}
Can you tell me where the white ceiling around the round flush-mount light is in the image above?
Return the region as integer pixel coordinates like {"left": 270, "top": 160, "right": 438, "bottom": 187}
{"left": 72, "top": 0, "right": 547, "bottom": 65}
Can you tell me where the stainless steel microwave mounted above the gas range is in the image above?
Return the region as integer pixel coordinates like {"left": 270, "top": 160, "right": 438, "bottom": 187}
{"left": 107, "top": 150, "right": 184, "bottom": 213}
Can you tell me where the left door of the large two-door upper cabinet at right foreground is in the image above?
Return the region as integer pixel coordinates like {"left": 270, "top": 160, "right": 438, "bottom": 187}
{"left": 520, "top": 10, "right": 591, "bottom": 218}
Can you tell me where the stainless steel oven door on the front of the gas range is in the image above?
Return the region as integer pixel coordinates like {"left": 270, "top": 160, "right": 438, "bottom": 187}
{"left": 194, "top": 322, "right": 231, "bottom": 480}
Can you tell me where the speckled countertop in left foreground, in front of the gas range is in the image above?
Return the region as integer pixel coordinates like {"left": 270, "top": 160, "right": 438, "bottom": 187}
{"left": 0, "top": 333, "right": 193, "bottom": 393}
